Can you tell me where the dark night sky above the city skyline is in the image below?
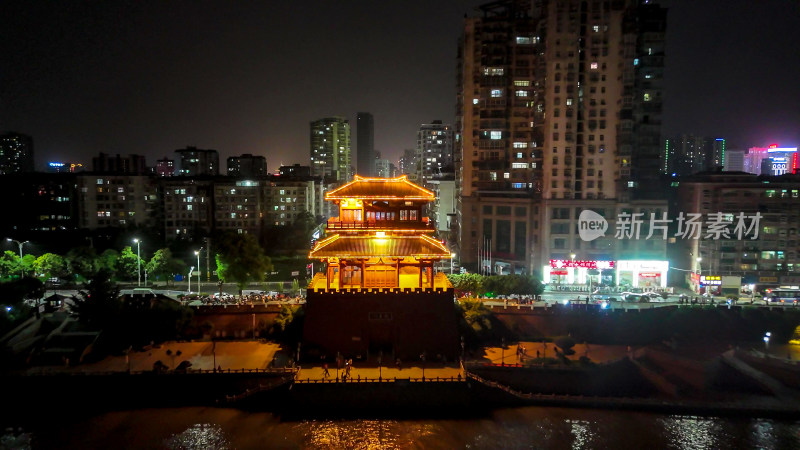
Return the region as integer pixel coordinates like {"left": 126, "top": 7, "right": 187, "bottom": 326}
{"left": 0, "top": 0, "right": 800, "bottom": 170}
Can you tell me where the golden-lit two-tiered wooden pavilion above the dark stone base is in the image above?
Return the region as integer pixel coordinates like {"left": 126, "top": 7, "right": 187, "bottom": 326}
{"left": 309, "top": 176, "right": 451, "bottom": 289}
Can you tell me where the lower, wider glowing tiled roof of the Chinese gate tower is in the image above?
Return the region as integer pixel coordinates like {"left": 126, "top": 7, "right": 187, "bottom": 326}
{"left": 309, "top": 234, "right": 451, "bottom": 259}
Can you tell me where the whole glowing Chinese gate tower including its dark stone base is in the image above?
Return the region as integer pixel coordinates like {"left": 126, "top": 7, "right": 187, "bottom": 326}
{"left": 303, "top": 175, "right": 459, "bottom": 359}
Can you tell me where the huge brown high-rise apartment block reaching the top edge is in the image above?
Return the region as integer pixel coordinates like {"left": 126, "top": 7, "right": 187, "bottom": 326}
{"left": 455, "top": 0, "right": 667, "bottom": 281}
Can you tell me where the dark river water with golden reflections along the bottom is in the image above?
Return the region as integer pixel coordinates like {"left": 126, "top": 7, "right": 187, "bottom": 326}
{"left": 6, "top": 407, "right": 800, "bottom": 450}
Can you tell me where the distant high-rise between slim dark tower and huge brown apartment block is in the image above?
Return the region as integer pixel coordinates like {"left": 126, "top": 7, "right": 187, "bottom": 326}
{"left": 415, "top": 120, "right": 454, "bottom": 183}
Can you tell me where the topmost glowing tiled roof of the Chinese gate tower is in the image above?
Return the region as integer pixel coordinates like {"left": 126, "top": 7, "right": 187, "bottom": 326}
{"left": 325, "top": 175, "right": 434, "bottom": 202}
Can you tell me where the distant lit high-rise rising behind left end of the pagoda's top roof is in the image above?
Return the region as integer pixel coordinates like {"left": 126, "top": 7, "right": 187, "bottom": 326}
{"left": 311, "top": 117, "right": 353, "bottom": 182}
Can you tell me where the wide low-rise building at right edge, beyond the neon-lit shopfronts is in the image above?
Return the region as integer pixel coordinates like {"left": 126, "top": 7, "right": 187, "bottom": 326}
{"left": 673, "top": 172, "right": 800, "bottom": 288}
